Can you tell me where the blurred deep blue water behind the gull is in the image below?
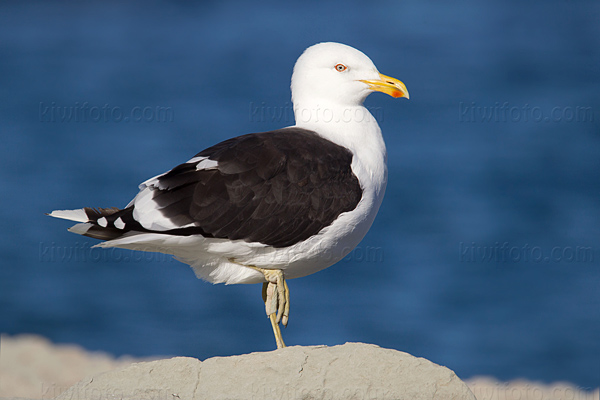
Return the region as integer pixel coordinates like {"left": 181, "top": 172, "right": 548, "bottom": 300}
{"left": 0, "top": 0, "right": 600, "bottom": 387}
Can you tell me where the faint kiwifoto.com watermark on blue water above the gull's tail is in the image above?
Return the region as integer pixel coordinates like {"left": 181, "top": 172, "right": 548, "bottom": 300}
{"left": 38, "top": 101, "right": 175, "bottom": 123}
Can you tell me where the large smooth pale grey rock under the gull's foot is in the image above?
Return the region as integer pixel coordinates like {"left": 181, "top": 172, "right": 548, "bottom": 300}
{"left": 57, "top": 343, "right": 475, "bottom": 400}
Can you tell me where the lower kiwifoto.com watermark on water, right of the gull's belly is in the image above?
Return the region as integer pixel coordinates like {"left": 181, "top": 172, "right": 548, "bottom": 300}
{"left": 458, "top": 242, "right": 594, "bottom": 263}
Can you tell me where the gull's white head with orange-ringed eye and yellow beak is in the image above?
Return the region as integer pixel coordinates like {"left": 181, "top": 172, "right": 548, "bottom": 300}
{"left": 291, "top": 42, "right": 408, "bottom": 107}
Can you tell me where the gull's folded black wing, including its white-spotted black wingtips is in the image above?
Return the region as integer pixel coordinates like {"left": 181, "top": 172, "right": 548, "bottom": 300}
{"left": 79, "top": 128, "right": 362, "bottom": 247}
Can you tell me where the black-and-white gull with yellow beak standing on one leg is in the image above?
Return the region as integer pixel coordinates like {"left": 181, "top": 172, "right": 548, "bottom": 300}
{"left": 49, "top": 43, "right": 408, "bottom": 348}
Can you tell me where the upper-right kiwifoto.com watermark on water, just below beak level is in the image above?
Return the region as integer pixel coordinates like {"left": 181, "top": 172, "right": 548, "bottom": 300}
{"left": 458, "top": 101, "right": 594, "bottom": 123}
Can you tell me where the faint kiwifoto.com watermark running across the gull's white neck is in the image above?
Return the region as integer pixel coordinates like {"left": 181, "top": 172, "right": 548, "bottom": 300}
{"left": 248, "top": 102, "right": 383, "bottom": 124}
